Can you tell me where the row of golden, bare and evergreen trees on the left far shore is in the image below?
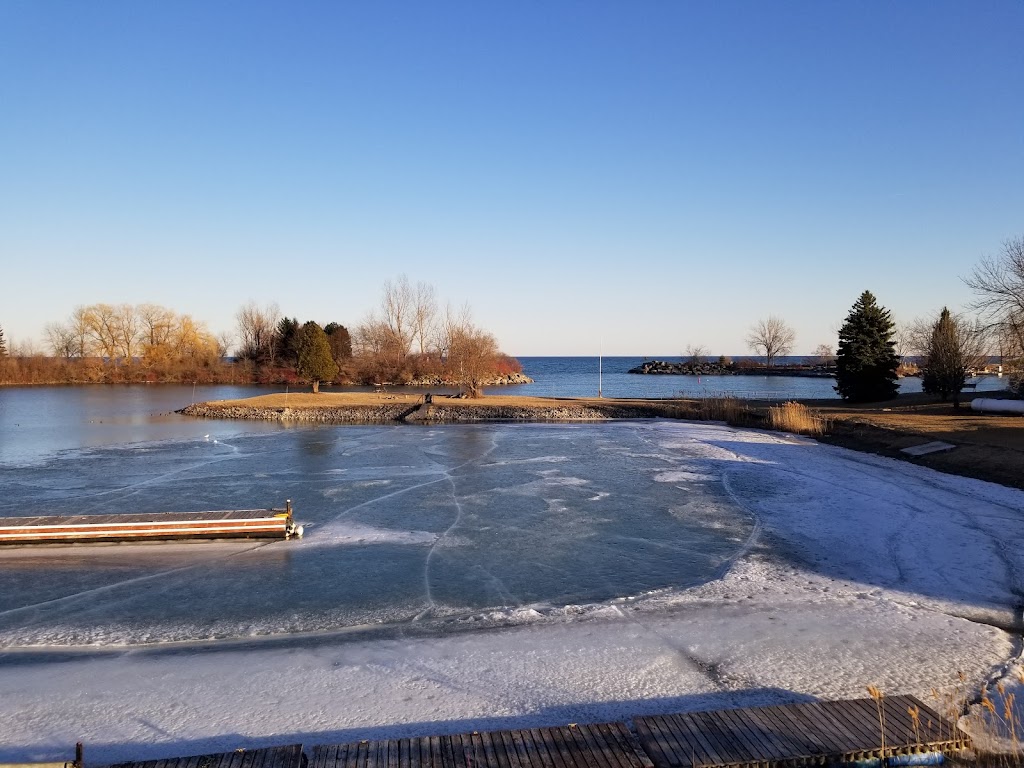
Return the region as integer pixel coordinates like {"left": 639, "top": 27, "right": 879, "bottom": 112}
{"left": 0, "top": 275, "right": 522, "bottom": 396}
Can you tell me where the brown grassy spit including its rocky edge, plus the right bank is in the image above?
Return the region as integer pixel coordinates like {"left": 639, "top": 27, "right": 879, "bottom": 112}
{"left": 180, "top": 392, "right": 1024, "bottom": 488}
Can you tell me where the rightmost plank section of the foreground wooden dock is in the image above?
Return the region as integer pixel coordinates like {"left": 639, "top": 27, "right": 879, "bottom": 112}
{"left": 635, "top": 696, "right": 967, "bottom": 768}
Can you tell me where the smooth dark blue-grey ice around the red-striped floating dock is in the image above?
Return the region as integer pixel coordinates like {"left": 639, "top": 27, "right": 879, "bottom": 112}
{"left": 0, "top": 425, "right": 754, "bottom": 647}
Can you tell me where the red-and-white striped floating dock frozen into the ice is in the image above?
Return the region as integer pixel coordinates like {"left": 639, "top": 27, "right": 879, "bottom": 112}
{"left": 0, "top": 501, "right": 302, "bottom": 544}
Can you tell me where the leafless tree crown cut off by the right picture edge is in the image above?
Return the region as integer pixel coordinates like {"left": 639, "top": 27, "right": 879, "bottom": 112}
{"left": 964, "top": 237, "right": 1024, "bottom": 357}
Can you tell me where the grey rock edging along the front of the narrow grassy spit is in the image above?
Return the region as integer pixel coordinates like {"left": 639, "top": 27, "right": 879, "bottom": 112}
{"left": 175, "top": 402, "right": 672, "bottom": 424}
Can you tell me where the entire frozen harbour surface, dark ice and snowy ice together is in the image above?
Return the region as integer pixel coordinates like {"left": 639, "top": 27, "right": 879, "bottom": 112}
{"left": 0, "top": 422, "right": 1024, "bottom": 763}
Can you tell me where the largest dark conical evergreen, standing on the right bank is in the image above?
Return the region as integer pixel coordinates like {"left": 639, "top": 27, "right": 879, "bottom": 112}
{"left": 836, "top": 291, "right": 899, "bottom": 402}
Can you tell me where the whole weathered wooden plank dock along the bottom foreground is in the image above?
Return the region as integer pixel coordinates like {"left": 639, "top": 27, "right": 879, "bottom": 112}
{"left": 79, "top": 696, "right": 970, "bottom": 768}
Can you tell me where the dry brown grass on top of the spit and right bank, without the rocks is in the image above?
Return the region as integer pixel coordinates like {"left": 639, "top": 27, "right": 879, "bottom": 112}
{"left": 203, "top": 392, "right": 1024, "bottom": 488}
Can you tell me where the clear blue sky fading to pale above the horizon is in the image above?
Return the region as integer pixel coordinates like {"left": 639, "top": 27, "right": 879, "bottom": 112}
{"left": 0, "top": 0, "right": 1024, "bottom": 355}
